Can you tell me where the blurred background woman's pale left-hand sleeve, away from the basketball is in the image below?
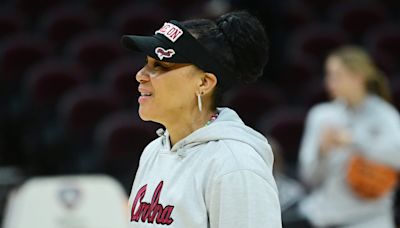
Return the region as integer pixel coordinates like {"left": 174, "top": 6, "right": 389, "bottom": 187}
{"left": 299, "top": 108, "right": 327, "bottom": 186}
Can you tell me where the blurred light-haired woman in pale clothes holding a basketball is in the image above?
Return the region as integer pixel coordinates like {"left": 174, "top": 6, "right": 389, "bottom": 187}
{"left": 299, "top": 46, "right": 400, "bottom": 228}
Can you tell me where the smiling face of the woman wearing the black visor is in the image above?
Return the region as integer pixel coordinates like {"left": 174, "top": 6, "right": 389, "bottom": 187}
{"left": 136, "top": 57, "right": 202, "bottom": 124}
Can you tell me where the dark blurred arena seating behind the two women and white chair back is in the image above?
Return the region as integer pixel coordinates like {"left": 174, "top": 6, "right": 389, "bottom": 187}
{"left": 0, "top": 0, "right": 400, "bottom": 224}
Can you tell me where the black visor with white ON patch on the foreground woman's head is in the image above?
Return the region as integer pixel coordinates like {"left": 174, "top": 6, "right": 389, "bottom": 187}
{"left": 121, "top": 20, "right": 234, "bottom": 87}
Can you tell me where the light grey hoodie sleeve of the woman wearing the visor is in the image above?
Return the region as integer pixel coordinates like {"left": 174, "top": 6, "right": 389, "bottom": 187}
{"left": 209, "top": 170, "right": 282, "bottom": 228}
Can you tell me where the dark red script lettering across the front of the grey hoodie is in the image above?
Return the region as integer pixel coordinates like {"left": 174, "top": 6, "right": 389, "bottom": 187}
{"left": 131, "top": 181, "right": 174, "bottom": 225}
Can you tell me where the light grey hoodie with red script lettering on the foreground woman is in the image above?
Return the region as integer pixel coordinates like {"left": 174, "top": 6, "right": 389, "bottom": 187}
{"left": 129, "top": 108, "right": 282, "bottom": 228}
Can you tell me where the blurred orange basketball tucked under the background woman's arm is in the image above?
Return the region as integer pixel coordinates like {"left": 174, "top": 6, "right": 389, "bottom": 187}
{"left": 347, "top": 155, "right": 398, "bottom": 199}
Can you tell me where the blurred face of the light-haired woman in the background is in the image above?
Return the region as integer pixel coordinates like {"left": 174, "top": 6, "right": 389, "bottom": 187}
{"left": 325, "top": 56, "right": 364, "bottom": 100}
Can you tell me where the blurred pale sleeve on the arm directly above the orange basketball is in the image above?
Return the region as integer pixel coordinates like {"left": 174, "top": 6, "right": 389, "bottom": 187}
{"left": 353, "top": 109, "right": 400, "bottom": 170}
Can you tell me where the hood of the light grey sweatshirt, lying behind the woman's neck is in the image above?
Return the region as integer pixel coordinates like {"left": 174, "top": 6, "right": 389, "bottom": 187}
{"left": 158, "top": 108, "right": 273, "bottom": 165}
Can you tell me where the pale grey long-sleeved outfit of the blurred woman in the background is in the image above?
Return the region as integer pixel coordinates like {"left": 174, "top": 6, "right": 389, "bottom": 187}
{"left": 299, "top": 95, "right": 400, "bottom": 228}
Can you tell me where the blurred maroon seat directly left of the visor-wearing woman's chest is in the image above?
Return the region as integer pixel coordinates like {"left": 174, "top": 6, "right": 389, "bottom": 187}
{"left": 94, "top": 111, "right": 159, "bottom": 192}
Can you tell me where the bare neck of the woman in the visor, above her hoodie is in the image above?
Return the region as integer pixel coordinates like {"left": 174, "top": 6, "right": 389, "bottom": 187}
{"left": 164, "top": 110, "right": 216, "bottom": 146}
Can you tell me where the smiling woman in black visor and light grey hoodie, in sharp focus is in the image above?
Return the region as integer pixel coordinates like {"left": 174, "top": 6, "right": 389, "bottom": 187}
{"left": 122, "top": 12, "right": 281, "bottom": 228}
